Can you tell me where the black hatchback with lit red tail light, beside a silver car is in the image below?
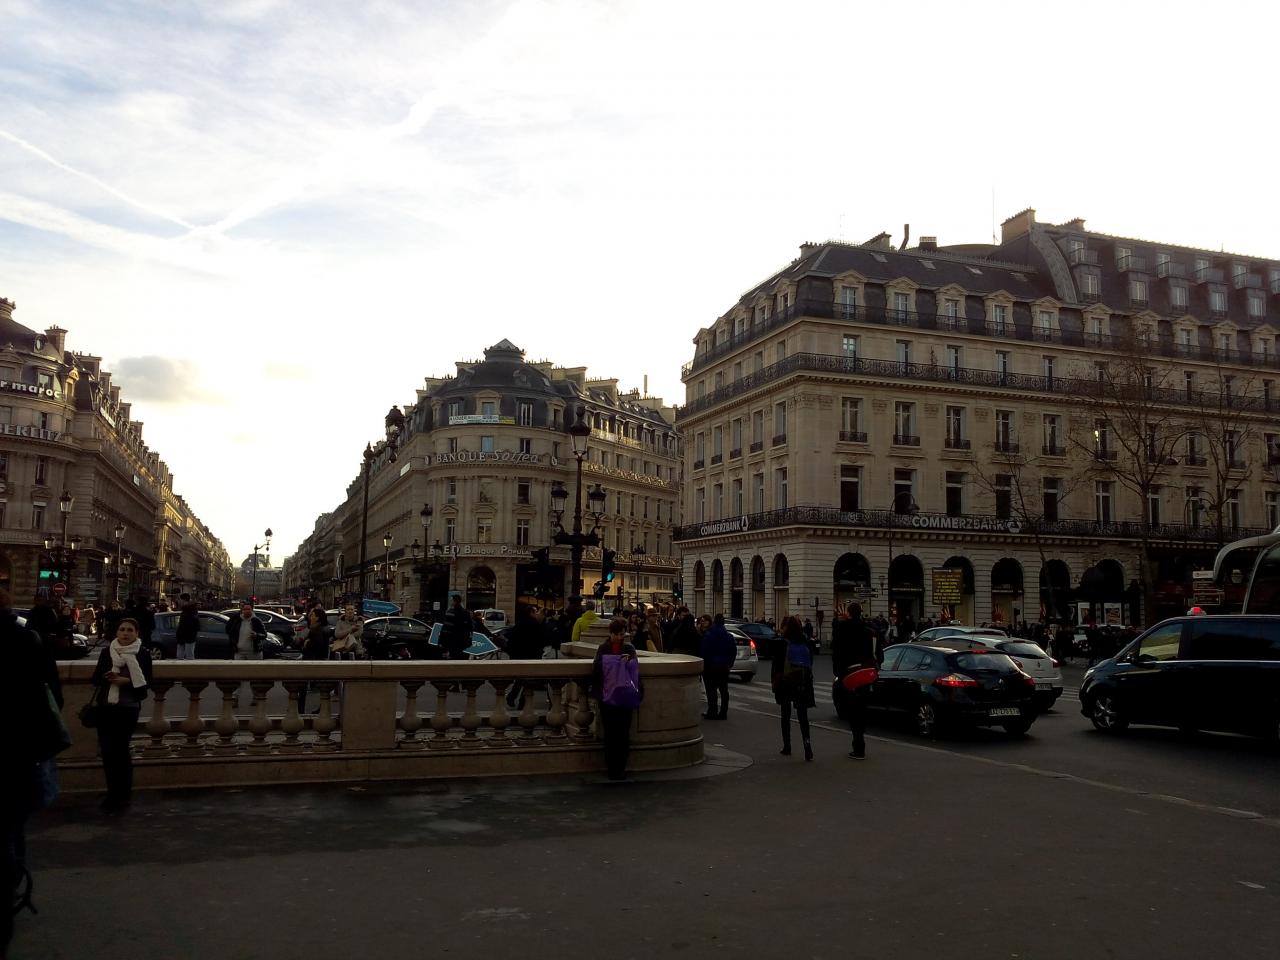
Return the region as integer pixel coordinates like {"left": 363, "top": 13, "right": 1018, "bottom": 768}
{"left": 849, "top": 641, "right": 1037, "bottom": 736}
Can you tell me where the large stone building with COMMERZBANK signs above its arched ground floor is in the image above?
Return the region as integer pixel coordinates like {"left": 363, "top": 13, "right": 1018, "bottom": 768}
{"left": 676, "top": 210, "right": 1280, "bottom": 632}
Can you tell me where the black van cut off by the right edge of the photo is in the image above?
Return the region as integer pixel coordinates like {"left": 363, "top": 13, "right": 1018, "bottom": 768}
{"left": 1080, "top": 616, "right": 1280, "bottom": 739}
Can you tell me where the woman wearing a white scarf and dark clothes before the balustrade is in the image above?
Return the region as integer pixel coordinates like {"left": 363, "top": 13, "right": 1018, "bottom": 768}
{"left": 92, "top": 617, "right": 151, "bottom": 813}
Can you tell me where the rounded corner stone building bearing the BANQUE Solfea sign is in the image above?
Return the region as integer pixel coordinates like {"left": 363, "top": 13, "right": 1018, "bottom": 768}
{"left": 316, "top": 340, "right": 680, "bottom": 613}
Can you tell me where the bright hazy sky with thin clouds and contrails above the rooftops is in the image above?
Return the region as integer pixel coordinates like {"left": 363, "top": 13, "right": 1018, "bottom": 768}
{"left": 0, "top": 0, "right": 1280, "bottom": 563}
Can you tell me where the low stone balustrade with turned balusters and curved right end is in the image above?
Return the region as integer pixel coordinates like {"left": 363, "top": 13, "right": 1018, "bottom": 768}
{"left": 59, "top": 643, "right": 703, "bottom": 790}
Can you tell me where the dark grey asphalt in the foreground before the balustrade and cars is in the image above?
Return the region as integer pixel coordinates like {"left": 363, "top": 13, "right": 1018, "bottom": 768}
{"left": 14, "top": 667, "right": 1280, "bottom": 960}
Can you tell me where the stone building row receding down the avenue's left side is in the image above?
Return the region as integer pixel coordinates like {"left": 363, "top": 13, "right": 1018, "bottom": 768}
{"left": 0, "top": 298, "right": 232, "bottom": 603}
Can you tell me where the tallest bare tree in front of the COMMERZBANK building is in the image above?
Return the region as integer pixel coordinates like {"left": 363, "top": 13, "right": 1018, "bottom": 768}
{"left": 1068, "top": 332, "right": 1187, "bottom": 624}
